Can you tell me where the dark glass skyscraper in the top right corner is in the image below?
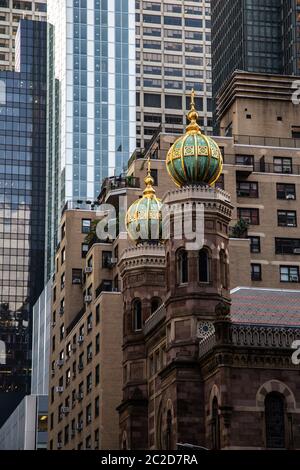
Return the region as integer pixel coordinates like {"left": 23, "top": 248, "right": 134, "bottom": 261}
{"left": 211, "top": 0, "right": 300, "bottom": 101}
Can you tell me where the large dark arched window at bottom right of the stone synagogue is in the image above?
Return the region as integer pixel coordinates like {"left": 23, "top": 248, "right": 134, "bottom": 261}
{"left": 265, "top": 392, "right": 285, "bottom": 449}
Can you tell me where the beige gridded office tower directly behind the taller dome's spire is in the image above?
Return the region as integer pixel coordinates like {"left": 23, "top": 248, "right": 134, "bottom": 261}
{"left": 135, "top": 0, "right": 212, "bottom": 149}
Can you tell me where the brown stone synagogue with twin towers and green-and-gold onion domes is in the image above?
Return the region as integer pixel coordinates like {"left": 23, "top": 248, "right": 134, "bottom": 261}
{"left": 119, "top": 93, "right": 300, "bottom": 449}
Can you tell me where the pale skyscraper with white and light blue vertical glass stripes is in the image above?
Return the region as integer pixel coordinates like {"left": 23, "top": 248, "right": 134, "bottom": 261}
{"left": 47, "top": 0, "right": 136, "bottom": 275}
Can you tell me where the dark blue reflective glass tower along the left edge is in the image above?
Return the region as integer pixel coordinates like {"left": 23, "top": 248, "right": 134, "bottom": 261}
{"left": 0, "top": 20, "right": 47, "bottom": 425}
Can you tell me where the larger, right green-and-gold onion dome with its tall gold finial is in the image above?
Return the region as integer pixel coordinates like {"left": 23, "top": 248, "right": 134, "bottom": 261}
{"left": 166, "top": 90, "right": 223, "bottom": 187}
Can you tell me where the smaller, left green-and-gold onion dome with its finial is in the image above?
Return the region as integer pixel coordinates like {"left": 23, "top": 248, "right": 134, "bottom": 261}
{"left": 125, "top": 159, "right": 162, "bottom": 243}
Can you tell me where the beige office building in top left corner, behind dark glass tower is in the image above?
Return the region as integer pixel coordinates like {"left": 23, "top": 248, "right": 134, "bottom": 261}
{"left": 0, "top": 0, "right": 47, "bottom": 70}
